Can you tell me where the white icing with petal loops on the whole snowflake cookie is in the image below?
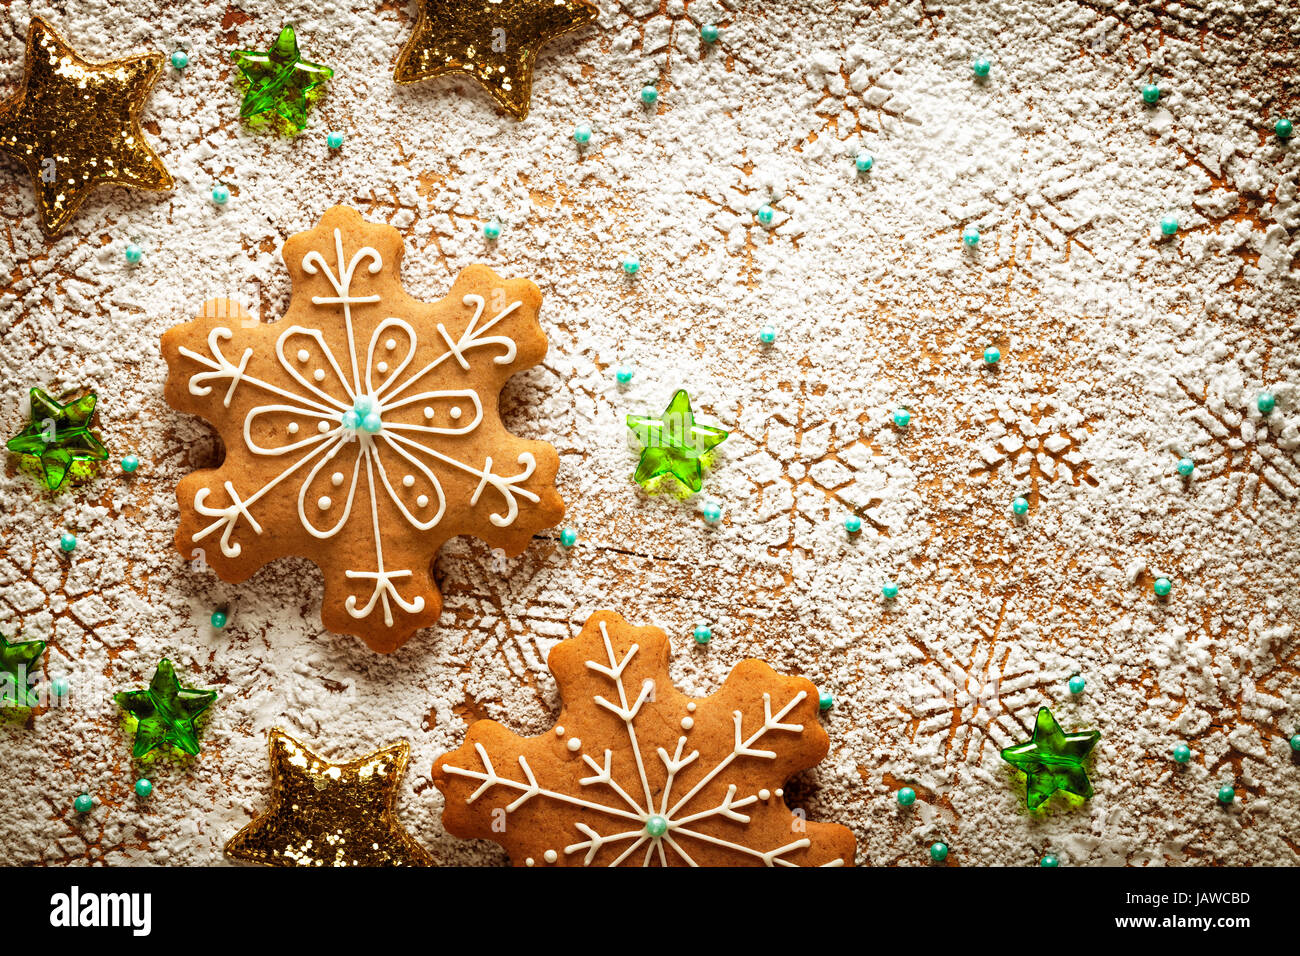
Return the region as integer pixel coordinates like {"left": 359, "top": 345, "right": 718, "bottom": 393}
{"left": 179, "top": 229, "right": 540, "bottom": 627}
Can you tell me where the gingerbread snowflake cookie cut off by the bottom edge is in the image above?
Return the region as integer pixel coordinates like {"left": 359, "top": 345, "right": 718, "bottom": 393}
{"left": 433, "top": 611, "right": 855, "bottom": 866}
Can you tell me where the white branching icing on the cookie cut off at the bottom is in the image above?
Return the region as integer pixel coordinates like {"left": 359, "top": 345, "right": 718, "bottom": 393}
{"left": 442, "top": 620, "right": 845, "bottom": 866}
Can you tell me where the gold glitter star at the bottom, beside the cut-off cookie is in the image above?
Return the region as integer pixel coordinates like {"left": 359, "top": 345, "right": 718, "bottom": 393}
{"left": 226, "top": 730, "right": 433, "bottom": 866}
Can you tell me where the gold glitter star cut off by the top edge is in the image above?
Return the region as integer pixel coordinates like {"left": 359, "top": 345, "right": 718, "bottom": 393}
{"left": 393, "top": 0, "right": 599, "bottom": 120}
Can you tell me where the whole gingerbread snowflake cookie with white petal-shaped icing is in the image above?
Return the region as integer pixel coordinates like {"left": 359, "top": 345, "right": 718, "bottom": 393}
{"left": 163, "top": 207, "right": 564, "bottom": 652}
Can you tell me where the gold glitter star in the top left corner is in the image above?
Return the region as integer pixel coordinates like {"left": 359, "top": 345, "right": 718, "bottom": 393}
{"left": 0, "top": 17, "right": 172, "bottom": 237}
